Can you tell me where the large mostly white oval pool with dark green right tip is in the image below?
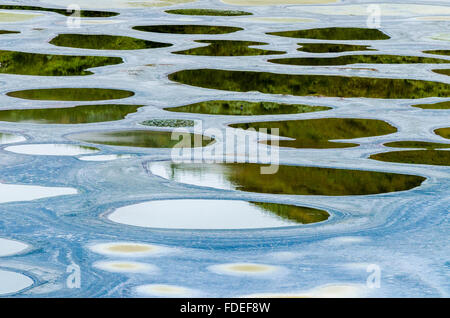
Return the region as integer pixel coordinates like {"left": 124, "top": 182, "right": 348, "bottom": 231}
{"left": 108, "top": 199, "right": 329, "bottom": 230}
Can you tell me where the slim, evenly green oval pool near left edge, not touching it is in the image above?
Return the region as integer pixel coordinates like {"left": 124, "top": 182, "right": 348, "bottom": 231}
{"left": 6, "top": 88, "right": 134, "bottom": 101}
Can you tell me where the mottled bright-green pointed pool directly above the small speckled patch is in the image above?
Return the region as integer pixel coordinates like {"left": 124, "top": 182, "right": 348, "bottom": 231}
{"left": 165, "top": 100, "right": 331, "bottom": 116}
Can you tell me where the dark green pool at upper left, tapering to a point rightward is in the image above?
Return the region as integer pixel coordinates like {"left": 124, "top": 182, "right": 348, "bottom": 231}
{"left": 50, "top": 34, "right": 172, "bottom": 50}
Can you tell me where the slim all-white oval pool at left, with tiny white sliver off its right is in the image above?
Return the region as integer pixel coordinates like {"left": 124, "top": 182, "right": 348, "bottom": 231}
{"left": 5, "top": 144, "right": 99, "bottom": 156}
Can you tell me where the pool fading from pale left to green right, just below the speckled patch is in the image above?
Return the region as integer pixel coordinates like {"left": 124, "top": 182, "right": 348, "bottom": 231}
{"left": 72, "top": 130, "right": 212, "bottom": 148}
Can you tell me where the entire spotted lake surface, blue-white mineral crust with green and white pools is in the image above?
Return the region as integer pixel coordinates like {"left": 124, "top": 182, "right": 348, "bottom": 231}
{"left": 0, "top": 0, "right": 450, "bottom": 297}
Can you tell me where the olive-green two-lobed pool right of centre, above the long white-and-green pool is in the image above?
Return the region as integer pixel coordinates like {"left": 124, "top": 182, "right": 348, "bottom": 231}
{"left": 230, "top": 118, "right": 397, "bottom": 148}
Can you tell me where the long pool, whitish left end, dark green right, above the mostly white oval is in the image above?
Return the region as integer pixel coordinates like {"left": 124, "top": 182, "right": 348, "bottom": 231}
{"left": 163, "top": 163, "right": 425, "bottom": 196}
